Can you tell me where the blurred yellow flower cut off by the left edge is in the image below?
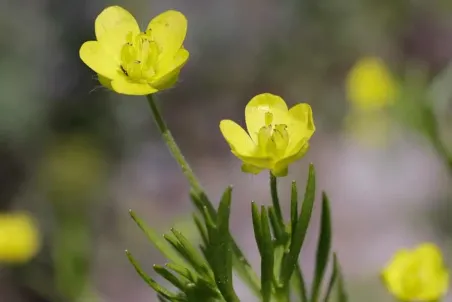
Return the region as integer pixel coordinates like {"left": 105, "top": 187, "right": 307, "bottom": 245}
{"left": 0, "top": 213, "right": 40, "bottom": 263}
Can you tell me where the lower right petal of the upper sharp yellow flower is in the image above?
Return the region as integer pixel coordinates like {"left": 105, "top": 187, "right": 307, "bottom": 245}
{"left": 150, "top": 49, "right": 190, "bottom": 89}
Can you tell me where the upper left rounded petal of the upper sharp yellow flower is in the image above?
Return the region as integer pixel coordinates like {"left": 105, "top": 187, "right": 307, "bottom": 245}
{"left": 94, "top": 6, "right": 140, "bottom": 64}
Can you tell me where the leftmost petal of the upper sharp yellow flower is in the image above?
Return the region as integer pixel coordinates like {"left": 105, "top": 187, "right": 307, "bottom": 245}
{"left": 79, "top": 41, "right": 119, "bottom": 79}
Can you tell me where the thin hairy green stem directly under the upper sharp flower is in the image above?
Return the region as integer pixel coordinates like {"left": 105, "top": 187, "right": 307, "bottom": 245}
{"left": 146, "top": 94, "right": 203, "bottom": 194}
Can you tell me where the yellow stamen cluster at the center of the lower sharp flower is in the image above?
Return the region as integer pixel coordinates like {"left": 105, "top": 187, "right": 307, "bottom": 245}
{"left": 258, "top": 112, "right": 289, "bottom": 157}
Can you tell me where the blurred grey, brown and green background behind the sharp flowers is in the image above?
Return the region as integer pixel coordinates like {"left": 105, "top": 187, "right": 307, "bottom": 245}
{"left": 0, "top": 0, "right": 452, "bottom": 302}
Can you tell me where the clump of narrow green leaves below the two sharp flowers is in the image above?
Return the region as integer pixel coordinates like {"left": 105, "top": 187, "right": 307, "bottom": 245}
{"left": 126, "top": 165, "right": 347, "bottom": 302}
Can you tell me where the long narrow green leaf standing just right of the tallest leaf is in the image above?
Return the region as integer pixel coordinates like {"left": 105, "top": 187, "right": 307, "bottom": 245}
{"left": 311, "top": 192, "right": 331, "bottom": 302}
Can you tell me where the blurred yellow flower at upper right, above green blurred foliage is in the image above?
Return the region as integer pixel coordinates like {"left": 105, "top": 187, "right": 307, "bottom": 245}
{"left": 346, "top": 57, "right": 396, "bottom": 110}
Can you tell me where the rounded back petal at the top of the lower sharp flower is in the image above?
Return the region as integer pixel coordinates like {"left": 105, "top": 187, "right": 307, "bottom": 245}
{"left": 245, "top": 93, "right": 289, "bottom": 142}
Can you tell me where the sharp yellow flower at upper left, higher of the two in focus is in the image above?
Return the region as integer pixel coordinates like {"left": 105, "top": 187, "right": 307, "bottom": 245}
{"left": 80, "top": 6, "right": 189, "bottom": 95}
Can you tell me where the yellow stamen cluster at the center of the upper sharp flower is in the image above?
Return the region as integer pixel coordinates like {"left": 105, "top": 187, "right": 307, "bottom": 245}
{"left": 121, "top": 32, "right": 160, "bottom": 82}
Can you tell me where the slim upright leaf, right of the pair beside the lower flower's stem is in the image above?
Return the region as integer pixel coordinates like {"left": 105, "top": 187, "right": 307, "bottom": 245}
{"left": 261, "top": 206, "right": 274, "bottom": 302}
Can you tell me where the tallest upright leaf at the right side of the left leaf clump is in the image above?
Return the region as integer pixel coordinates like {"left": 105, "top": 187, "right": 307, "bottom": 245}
{"left": 208, "top": 187, "right": 240, "bottom": 302}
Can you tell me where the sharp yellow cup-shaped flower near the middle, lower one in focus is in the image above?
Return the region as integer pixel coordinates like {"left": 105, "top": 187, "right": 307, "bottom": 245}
{"left": 220, "top": 93, "right": 315, "bottom": 176}
